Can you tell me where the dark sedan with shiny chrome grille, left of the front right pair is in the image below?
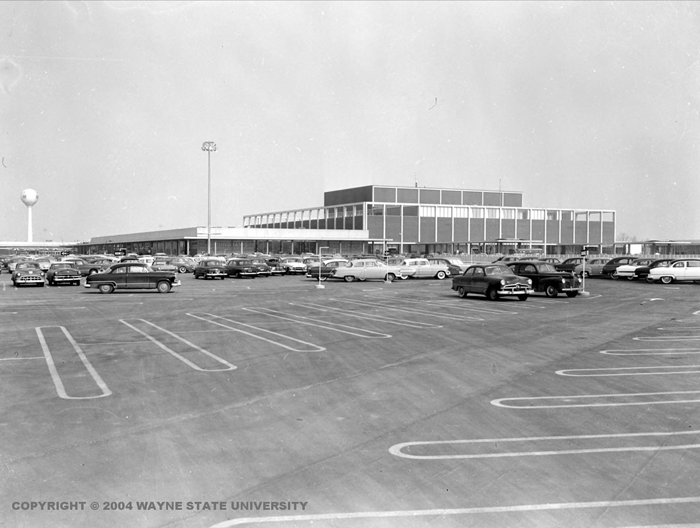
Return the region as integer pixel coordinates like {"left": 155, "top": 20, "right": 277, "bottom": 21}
{"left": 452, "top": 264, "right": 533, "bottom": 301}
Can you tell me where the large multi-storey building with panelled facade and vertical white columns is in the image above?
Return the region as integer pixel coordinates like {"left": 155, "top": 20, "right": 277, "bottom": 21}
{"left": 243, "top": 185, "right": 616, "bottom": 254}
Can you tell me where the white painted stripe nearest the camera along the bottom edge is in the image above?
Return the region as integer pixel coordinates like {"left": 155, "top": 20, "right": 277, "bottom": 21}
{"left": 211, "top": 497, "right": 700, "bottom": 528}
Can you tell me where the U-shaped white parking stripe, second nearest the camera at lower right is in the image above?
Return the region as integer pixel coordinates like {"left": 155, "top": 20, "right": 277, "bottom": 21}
{"left": 389, "top": 431, "right": 700, "bottom": 460}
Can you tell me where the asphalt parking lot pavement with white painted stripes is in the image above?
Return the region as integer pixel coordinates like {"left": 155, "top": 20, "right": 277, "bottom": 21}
{"left": 0, "top": 274, "right": 700, "bottom": 527}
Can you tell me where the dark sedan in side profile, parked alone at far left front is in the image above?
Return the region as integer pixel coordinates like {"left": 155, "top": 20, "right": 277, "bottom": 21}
{"left": 85, "top": 262, "right": 180, "bottom": 293}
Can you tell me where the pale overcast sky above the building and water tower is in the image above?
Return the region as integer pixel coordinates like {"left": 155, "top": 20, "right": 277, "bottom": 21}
{"left": 0, "top": 1, "right": 700, "bottom": 241}
